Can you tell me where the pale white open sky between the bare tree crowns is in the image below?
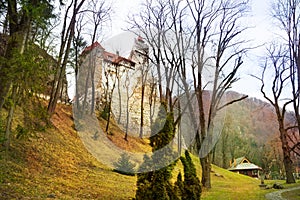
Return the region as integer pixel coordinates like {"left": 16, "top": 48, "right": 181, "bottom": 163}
{"left": 68, "top": 0, "right": 273, "bottom": 99}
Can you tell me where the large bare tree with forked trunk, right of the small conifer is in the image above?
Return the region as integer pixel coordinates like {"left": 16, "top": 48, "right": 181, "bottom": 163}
{"left": 182, "top": 1, "right": 248, "bottom": 188}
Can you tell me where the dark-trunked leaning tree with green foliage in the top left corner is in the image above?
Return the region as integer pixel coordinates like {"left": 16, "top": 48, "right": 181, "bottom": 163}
{"left": 0, "top": 0, "right": 54, "bottom": 110}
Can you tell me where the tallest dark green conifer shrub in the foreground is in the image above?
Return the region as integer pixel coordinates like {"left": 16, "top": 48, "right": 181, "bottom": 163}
{"left": 135, "top": 104, "right": 178, "bottom": 200}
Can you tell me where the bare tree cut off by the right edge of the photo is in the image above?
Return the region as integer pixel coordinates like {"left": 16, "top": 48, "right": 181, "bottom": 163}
{"left": 272, "top": 0, "right": 300, "bottom": 156}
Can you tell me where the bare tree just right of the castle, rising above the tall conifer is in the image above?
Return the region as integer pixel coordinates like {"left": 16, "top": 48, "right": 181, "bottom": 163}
{"left": 129, "top": 0, "right": 170, "bottom": 105}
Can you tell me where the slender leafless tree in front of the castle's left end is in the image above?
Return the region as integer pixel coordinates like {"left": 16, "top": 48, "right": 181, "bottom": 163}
{"left": 75, "top": 0, "right": 111, "bottom": 114}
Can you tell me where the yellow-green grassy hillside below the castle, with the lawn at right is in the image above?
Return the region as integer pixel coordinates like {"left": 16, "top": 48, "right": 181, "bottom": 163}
{"left": 0, "top": 105, "right": 298, "bottom": 200}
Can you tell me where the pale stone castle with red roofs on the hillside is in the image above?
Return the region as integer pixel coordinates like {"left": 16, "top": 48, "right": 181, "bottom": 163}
{"left": 77, "top": 37, "right": 156, "bottom": 136}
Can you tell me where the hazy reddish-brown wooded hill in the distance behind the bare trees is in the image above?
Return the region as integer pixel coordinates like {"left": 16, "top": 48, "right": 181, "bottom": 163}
{"left": 180, "top": 91, "right": 293, "bottom": 145}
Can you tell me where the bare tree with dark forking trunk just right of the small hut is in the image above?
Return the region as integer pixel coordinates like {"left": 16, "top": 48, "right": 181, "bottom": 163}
{"left": 257, "top": 44, "right": 295, "bottom": 183}
